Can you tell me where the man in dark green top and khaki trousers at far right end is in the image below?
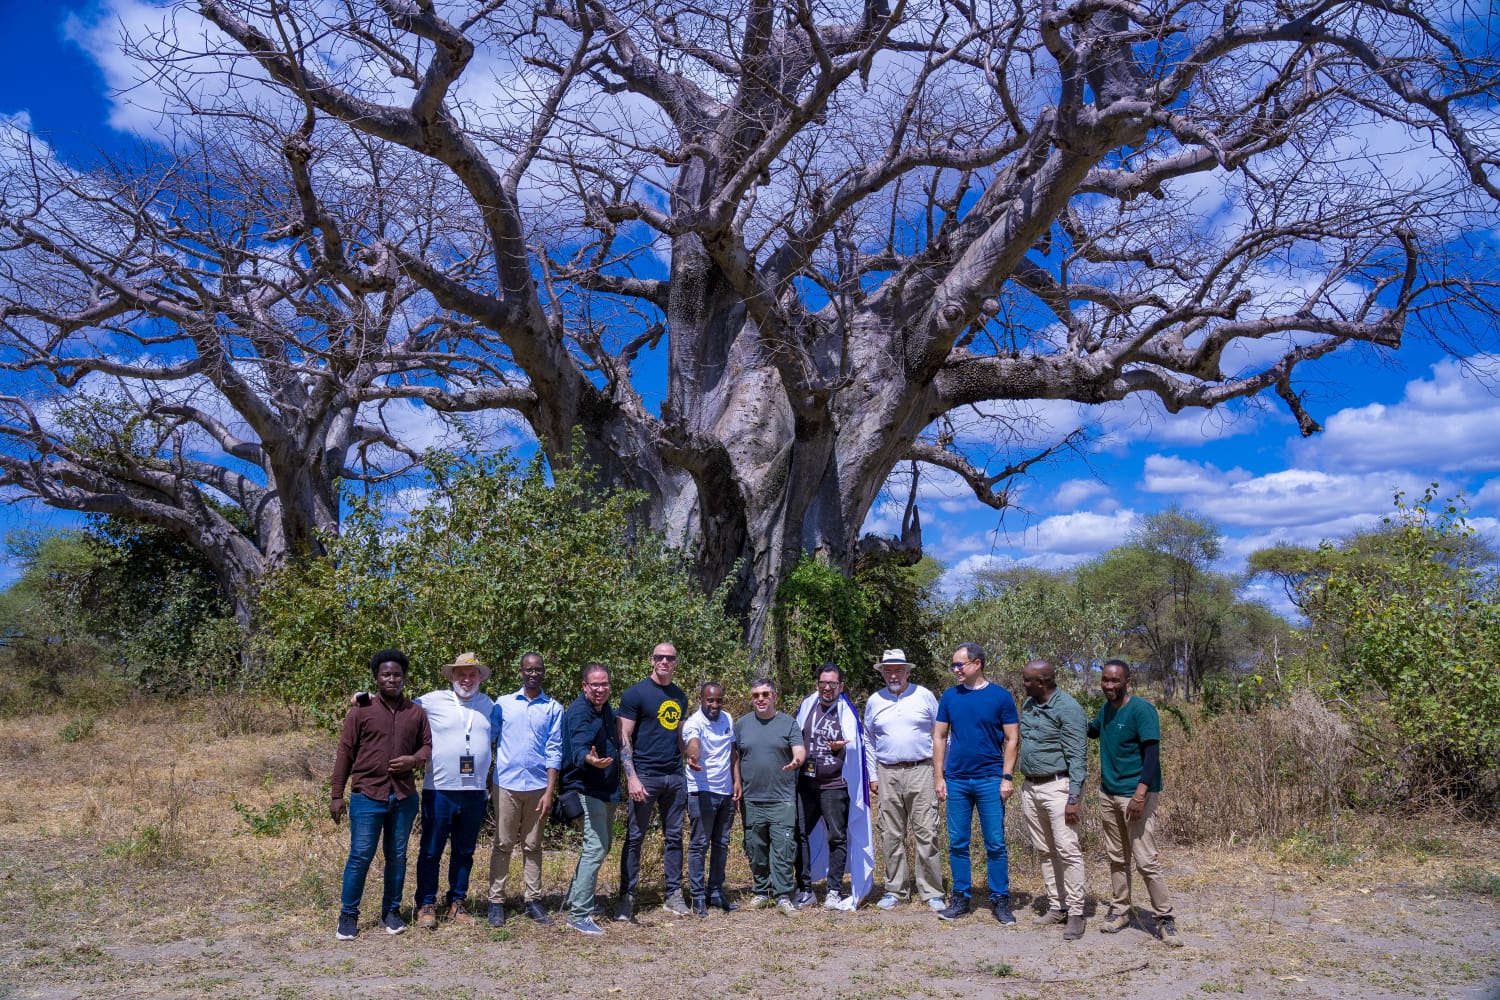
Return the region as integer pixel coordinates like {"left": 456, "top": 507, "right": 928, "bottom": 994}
{"left": 1089, "top": 660, "right": 1182, "bottom": 948}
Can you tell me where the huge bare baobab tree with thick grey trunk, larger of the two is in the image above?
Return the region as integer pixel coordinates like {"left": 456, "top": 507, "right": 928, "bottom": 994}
{"left": 2, "top": 0, "right": 1500, "bottom": 643}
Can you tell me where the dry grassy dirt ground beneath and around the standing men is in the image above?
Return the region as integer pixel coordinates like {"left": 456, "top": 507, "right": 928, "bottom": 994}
{"left": 0, "top": 708, "right": 1500, "bottom": 1000}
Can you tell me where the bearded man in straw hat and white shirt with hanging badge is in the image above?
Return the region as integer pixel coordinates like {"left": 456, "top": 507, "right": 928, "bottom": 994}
{"left": 417, "top": 652, "right": 495, "bottom": 930}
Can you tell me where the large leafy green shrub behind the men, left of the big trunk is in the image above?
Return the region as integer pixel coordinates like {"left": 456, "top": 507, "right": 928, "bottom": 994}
{"left": 255, "top": 456, "right": 749, "bottom": 718}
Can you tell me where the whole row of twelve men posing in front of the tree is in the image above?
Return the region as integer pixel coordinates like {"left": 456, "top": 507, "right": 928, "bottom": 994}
{"left": 330, "top": 643, "right": 1181, "bottom": 945}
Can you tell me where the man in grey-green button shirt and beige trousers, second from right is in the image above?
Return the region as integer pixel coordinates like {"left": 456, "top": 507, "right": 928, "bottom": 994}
{"left": 1020, "top": 660, "right": 1089, "bottom": 942}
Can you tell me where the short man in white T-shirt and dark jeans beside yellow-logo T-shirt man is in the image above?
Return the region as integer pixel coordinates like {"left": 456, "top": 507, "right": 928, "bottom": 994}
{"left": 683, "top": 681, "right": 740, "bottom": 916}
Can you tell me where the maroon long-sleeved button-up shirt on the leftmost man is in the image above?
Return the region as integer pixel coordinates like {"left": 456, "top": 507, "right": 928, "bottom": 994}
{"left": 330, "top": 696, "right": 432, "bottom": 802}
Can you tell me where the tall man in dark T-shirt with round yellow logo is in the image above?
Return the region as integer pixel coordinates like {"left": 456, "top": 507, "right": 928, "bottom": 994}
{"left": 615, "top": 642, "right": 689, "bottom": 922}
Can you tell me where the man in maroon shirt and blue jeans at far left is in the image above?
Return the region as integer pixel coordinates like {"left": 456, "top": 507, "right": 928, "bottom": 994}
{"left": 329, "top": 649, "right": 432, "bottom": 942}
